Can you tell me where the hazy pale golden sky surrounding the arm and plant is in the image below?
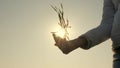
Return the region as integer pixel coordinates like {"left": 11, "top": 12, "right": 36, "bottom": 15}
{"left": 0, "top": 0, "right": 113, "bottom": 68}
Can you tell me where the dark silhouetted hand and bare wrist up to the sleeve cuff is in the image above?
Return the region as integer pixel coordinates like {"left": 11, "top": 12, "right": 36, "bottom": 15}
{"left": 52, "top": 33, "right": 90, "bottom": 54}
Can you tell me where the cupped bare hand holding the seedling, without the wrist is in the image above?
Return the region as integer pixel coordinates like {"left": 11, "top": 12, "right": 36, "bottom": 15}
{"left": 52, "top": 33, "right": 79, "bottom": 54}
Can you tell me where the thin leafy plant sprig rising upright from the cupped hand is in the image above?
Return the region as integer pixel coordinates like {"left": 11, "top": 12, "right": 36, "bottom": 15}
{"left": 51, "top": 4, "right": 71, "bottom": 40}
